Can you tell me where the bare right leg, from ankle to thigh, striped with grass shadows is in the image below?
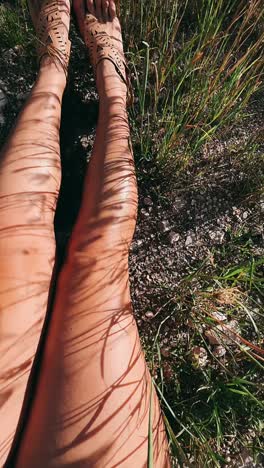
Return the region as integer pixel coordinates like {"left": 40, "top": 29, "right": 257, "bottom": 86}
{"left": 16, "top": 14, "right": 170, "bottom": 468}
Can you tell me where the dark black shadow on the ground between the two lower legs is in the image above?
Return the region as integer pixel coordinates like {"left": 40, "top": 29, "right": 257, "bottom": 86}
{"left": 55, "top": 89, "right": 98, "bottom": 257}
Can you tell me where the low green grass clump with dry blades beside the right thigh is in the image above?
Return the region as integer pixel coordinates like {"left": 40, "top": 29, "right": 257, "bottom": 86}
{"left": 147, "top": 250, "right": 264, "bottom": 468}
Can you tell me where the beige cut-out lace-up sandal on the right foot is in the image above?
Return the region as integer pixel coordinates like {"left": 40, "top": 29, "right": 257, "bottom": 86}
{"left": 84, "top": 14, "right": 133, "bottom": 105}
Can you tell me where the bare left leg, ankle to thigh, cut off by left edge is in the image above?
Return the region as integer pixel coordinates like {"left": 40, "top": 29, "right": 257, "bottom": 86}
{"left": 0, "top": 59, "right": 65, "bottom": 466}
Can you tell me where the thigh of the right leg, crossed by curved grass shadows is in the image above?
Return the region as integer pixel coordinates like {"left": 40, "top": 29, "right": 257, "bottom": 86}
{"left": 14, "top": 239, "right": 169, "bottom": 468}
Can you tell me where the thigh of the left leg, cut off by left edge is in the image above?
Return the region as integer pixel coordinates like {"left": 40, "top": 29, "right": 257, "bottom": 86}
{"left": 0, "top": 194, "right": 55, "bottom": 466}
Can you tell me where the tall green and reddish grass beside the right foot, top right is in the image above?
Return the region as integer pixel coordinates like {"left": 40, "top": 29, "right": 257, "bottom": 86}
{"left": 121, "top": 0, "right": 264, "bottom": 161}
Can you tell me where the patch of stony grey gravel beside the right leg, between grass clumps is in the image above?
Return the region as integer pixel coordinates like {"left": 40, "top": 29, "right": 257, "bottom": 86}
{"left": 131, "top": 127, "right": 264, "bottom": 324}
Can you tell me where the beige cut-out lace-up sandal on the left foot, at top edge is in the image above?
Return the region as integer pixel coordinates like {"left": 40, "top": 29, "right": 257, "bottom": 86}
{"left": 28, "top": 0, "right": 71, "bottom": 76}
